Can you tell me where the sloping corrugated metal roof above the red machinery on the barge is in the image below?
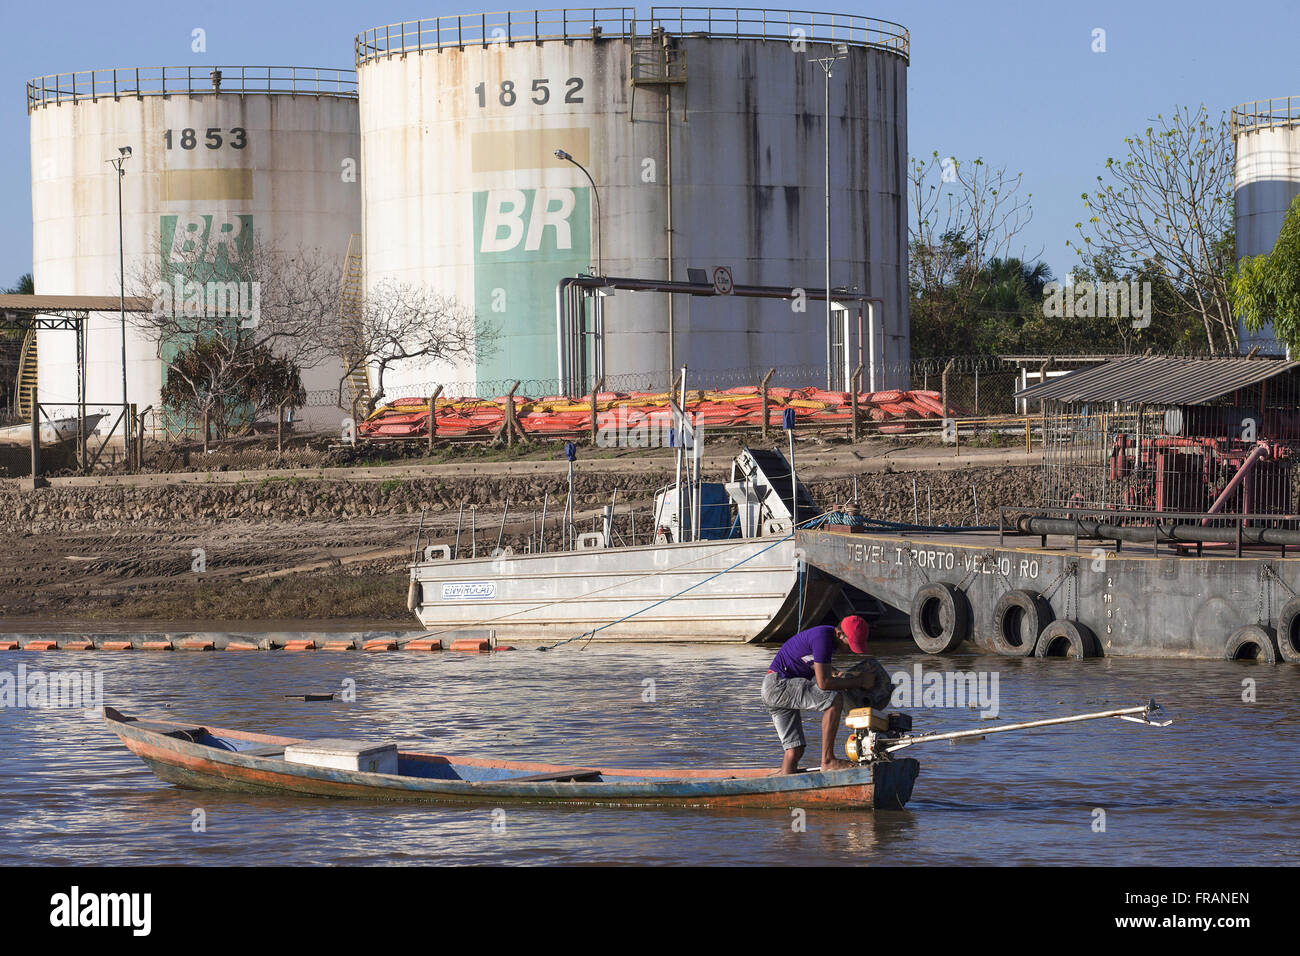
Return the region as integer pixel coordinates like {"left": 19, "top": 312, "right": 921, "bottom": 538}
{"left": 1015, "top": 356, "right": 1300, "bottom": 405}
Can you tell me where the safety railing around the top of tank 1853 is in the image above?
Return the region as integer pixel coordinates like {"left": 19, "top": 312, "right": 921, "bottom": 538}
{"left": 27, "top": 66, "right": 356, "bottom": 112}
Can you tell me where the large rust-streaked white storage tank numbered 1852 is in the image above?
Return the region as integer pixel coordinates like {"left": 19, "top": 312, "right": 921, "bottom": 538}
{"left": 356, "top": 7, "right": 909, "bottom": 395}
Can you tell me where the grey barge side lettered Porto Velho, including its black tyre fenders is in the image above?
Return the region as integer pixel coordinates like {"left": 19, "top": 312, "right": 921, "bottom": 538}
{"left": 798, "top": 512, "right": 1300, "bottom": 662}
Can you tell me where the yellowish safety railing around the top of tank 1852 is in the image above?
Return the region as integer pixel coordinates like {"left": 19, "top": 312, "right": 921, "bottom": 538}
{"left": 354, "top": 7, "right": 909, "bottom": 66}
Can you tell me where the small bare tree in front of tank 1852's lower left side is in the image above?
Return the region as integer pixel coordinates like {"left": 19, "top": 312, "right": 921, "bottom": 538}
{"left": 338, "top": 280, "right": 497, "bottom": 416}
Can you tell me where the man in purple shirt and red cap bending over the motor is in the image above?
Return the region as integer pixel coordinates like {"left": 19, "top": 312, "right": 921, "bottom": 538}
{"left": 762, "top": 615, "right": 879, "bottom": 774}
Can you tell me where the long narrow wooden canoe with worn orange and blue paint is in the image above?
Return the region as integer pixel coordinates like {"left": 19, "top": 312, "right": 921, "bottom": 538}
{"left": 104, "top": 708, "right": 919, "bottom": 810}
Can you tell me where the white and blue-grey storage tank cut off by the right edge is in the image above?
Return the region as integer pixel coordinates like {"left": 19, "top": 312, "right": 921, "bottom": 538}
{"left": 1231, "top": 96, "right": 1300, "bottom": 352}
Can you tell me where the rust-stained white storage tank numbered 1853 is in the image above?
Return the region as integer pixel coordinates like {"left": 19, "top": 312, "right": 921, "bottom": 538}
{"left": 27, "top": 66, "right": 361, "bottom": 427}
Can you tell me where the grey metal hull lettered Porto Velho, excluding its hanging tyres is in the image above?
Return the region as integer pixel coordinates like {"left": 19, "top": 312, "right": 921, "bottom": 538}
{"left": 798, "top": 531, "right": 1300, "bottom": 662}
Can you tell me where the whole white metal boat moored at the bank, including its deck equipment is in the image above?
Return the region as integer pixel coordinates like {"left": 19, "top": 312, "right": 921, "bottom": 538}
{"left": 408, "top": 449, "right": 841, "bottom": 643}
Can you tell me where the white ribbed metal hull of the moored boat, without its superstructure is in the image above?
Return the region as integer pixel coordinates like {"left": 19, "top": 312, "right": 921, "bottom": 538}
{"left": 411, "top": 537, "right": 840, "bottom": 644}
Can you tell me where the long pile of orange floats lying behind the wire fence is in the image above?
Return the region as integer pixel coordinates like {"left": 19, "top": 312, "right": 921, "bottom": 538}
{"left": 360, "top": 385, "right": 958, "bottom": 438}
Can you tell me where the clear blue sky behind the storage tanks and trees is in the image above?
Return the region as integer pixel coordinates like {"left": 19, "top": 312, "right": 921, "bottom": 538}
{"left": 0, "top": 0, "right": 1300, "bottom": 291}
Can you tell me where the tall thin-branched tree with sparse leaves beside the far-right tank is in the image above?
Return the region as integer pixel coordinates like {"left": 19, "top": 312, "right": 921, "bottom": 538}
{"left": 1070, "top": 104, "right": 1238, "bottom": 354}
